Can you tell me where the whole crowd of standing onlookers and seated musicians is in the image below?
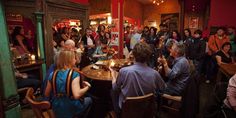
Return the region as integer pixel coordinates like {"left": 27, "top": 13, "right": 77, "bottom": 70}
{"left": 12, "top": 24, "right": 236, "bottom": 117}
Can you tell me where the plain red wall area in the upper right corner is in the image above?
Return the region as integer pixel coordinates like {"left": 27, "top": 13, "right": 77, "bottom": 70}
{"left": 208, "top": 0, "right": 236, "bottom": 28}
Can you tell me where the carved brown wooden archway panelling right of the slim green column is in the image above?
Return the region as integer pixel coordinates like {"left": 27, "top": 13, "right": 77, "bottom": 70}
{"left": 44, "top": 0, "right": 88, "bottom": 67}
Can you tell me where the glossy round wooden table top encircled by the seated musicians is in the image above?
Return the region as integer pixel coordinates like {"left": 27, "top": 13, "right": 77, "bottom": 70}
{"left": 82, "top": 59, "right": 129, "bottom": 81}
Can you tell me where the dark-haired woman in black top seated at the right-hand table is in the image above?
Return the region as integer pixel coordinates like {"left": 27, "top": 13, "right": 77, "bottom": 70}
{"left": 216, "top": 42, "right": 234, "bottom": 65}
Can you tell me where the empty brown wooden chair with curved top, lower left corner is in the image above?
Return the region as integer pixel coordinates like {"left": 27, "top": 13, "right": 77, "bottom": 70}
{"left": 25, "top": 88, "right": 54, "bottom": 118}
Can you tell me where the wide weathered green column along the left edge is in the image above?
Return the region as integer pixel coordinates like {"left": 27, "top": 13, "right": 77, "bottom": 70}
{"left": 0, "top": 0, "right": 21, "bottom": 118}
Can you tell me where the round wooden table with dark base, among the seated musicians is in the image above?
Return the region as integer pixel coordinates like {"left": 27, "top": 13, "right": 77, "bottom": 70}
{"left": 81, "top": 59, "right": 132, "bottom": 118}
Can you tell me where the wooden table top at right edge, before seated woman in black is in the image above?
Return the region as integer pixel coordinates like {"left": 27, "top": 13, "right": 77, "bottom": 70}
{"left": 220, "top": 64, "right": 236, "bottom": 77}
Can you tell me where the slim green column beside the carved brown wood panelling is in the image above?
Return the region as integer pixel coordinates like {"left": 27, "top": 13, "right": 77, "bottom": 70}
{"left": 34, "top": 12, "right": 46, "bottom": 79}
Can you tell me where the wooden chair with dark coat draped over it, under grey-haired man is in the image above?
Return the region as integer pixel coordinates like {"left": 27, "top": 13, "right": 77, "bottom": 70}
{"left": 160, "top": 73, "right": 199, "bottom": 118}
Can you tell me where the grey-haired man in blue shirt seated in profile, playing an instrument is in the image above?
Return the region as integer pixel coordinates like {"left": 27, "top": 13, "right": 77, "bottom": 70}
{"left": 158, "top": 43, "right": 190, "bottom": 95}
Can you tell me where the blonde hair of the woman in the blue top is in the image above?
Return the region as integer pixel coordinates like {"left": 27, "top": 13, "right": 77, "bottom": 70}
{"left": 57, "top": 50, "right": 75, "bottom": 69}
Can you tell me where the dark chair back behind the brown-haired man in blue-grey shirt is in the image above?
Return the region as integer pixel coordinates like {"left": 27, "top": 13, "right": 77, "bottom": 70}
{"left": 121, "top": 93, "right": 156, "bottom": 118}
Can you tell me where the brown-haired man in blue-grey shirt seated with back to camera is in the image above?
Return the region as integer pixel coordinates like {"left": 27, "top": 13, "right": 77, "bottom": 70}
{"left": 111, "top": 42, "right": 165, "bottom": 114}
